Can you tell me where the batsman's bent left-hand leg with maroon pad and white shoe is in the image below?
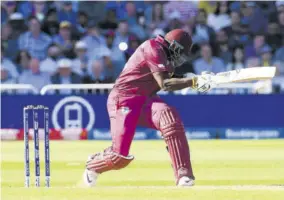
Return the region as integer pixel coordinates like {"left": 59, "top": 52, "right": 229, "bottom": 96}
{"left": 83, "top": 94, "right": 143, "bottom": 186}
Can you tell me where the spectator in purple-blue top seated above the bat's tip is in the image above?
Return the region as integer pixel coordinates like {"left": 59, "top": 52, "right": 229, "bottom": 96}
{"left": 245, "top": 33, "right": 265, "bottom": 59}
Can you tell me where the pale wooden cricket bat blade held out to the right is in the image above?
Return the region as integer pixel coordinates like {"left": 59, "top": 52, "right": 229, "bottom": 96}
{"left": 212, "top": 67, "right": 276, "bottom": 85}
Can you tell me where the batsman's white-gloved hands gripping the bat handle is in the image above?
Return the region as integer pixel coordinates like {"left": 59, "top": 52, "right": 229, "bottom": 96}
{"left": 192, "top": 71, "right": 216, "bottom": 93}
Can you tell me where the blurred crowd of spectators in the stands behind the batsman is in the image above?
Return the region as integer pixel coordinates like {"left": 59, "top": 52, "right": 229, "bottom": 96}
{"left": 1, "top": 1, "right": 284, "bottom": 93}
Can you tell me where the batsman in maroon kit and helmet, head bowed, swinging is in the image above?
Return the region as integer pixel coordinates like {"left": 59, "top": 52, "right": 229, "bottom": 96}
{"left": 83, "top": 29, "right": 212, "bottom": 186}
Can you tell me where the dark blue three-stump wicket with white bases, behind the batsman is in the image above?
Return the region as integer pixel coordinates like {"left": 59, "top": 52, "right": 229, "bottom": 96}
{"left": 23, "top": 105, "right": 50, "bottom": 187}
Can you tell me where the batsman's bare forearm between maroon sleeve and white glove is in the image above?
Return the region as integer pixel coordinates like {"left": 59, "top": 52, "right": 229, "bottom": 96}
{"left": 153, "top": 72, "right": 196, "bottom": 91}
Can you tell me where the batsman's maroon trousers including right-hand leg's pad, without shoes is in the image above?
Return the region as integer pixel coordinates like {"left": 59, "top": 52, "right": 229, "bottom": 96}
{"left": 107, "top": 91, "right": 193, "bottom": 181}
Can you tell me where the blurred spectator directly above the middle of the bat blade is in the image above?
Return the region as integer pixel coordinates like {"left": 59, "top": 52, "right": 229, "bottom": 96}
{"left": 226, "top": 46, "right": 245, "bottom": 71}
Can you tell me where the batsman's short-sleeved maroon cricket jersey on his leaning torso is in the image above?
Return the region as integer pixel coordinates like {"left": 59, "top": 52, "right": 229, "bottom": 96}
{"left": 115, "top": 36, "right": 173, "bottom": 96}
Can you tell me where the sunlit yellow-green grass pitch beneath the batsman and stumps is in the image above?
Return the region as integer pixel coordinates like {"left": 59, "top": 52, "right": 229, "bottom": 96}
{"left": 1, "top": 140, "right": 284, "bottom": 200}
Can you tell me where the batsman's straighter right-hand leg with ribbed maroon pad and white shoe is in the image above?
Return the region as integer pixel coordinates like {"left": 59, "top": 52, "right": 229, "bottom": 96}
{"left": 139, "top": 98, "right": 194, "bottom": 186}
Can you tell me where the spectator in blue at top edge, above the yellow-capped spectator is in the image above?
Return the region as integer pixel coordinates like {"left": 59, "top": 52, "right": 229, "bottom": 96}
{"left": 58, "top": 1, "right": 77, "bottom": 25}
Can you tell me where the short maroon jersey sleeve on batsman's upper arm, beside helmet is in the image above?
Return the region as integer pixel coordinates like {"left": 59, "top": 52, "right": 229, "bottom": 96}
{"left": 146, "top": 43, "right": 172, "bottom": 72}
